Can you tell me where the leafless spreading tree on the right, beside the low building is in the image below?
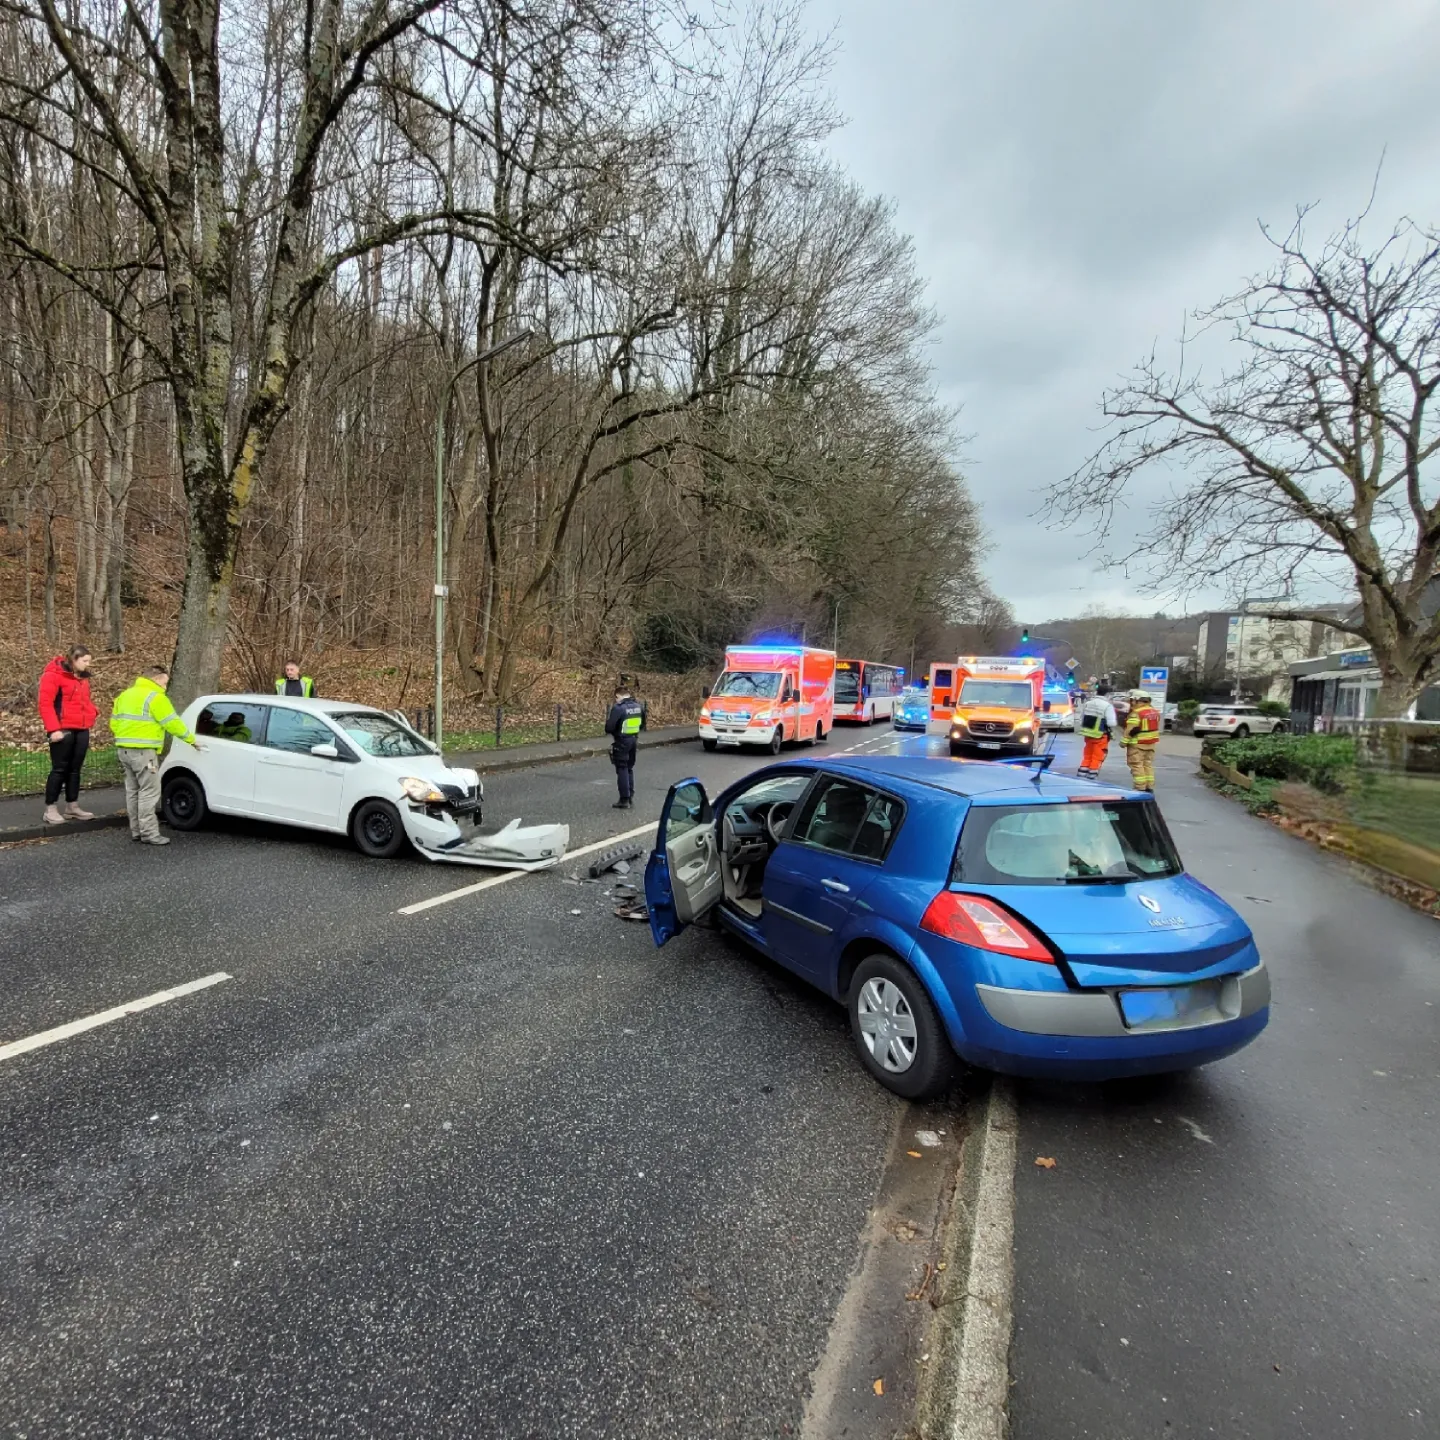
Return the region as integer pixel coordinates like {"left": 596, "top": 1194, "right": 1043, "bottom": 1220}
{"left": 1048, "top": 212, "right": 1440, "bottom": 716}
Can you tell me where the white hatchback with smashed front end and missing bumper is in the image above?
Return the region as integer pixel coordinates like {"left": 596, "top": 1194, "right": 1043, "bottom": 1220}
{"left": 160, "top": 696, "right": 484, "bottom": 860}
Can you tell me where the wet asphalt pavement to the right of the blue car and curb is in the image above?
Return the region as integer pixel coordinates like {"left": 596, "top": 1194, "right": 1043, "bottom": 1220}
{"left": 1011, "top": 737, "right": 1440, "bottom": 1440}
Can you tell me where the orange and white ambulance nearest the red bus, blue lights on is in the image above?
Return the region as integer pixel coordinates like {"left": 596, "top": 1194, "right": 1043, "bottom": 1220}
{"left": 700, "top": 645, "right": 835, "bottom": 755}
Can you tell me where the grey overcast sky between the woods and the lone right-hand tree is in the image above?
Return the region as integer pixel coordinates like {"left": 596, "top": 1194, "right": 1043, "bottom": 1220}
{"left": 811, "top": 0, "right": 1440, "bottom": 621}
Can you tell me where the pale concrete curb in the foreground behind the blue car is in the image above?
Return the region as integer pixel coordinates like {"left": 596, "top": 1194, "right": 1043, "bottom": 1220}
{"left": 922, "top": 1077, "right": 1018, "bottom": 1440}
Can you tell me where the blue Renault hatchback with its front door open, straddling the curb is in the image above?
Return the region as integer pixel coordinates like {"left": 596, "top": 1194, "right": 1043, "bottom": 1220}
{"left": 645, "top": 756, "right": 1270, "bottom": 1099}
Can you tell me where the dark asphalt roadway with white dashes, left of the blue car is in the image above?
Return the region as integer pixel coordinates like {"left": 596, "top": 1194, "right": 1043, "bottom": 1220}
{"left": 0, "top": 737, "right": 935, "bottom": 1440}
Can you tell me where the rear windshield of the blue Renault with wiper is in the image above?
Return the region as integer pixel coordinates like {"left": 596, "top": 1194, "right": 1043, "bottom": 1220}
{"left": 950, "top": 801, "right": 1182, "bottom": 886}
